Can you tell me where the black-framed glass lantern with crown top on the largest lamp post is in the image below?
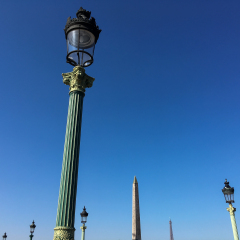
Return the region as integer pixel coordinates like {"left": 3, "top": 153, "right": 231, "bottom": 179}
{"left": 64, "top": 7, "right": 101, "bottom": 67}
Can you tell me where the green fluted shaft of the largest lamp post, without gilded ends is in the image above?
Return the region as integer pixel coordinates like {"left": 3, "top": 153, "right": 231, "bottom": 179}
{"left": 56, "top": 91, "right": 85, "bottom": 228}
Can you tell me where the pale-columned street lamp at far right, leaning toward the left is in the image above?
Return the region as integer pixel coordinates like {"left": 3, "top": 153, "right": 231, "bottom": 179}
{"left": 222, "top": 179, "right": 239, "bottom": 240}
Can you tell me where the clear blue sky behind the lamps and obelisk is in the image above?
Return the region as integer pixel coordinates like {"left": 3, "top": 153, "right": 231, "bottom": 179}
{"left": 0, "top": 0, "right": 240, "bottom": 240}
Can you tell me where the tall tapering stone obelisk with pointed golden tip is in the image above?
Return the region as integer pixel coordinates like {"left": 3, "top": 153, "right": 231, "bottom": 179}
{"left": 132, "top": 176, "right": 141, "bottom": 240}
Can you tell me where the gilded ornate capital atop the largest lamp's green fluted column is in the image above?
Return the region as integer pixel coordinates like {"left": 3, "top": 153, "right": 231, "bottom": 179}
{"left": 62, "top": 66, "right": 95, "bottom": 92}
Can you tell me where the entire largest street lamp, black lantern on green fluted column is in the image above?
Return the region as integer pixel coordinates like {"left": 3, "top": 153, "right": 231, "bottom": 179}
{"left": 54, "top": 7, "right": 101, "bottom": 240}
